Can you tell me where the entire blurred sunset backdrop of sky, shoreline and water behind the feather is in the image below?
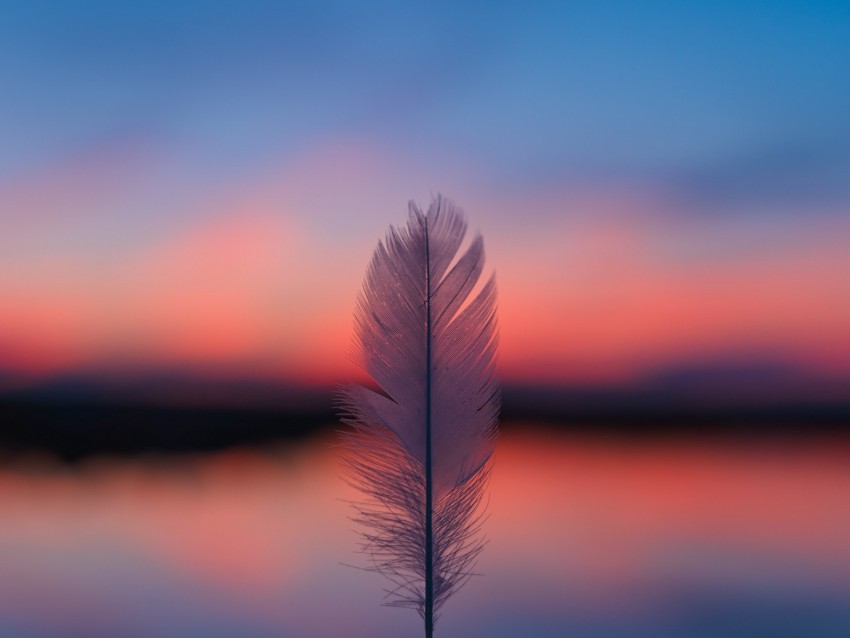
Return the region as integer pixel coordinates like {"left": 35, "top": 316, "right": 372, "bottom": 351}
{"left": 0, "top": 0, "right": 850, "bottom": 638}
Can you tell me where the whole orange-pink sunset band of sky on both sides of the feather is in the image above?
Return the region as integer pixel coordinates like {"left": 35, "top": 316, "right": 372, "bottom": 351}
{"left": 0, "top": 140, "right": 850, "bottom": 390}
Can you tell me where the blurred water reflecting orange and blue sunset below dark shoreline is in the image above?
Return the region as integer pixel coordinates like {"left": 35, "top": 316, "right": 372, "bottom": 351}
{"left": 0, "top": 426, "right": 850, "bottom": 638}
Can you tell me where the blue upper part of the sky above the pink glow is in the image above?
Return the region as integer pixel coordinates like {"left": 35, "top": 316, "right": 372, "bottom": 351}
{"left": 6, "top": 2, "right": 850, "bottom": 201}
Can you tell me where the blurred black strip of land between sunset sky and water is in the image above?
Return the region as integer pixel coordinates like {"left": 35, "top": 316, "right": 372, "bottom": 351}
{"left": 0, "top": 367, "right": 850, "bottom": 460}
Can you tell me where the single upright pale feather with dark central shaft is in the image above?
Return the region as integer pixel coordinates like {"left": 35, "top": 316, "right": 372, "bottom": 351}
{"left": 340, "top": 197, "right": 500, "bottom": 637}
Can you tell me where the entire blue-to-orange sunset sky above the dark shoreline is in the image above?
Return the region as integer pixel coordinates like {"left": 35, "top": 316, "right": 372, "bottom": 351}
{"left": 0, "top": 0, "right": 850, "bottom": 396}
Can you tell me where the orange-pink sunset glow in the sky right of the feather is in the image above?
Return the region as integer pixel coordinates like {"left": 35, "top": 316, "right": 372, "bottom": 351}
{"left": 491, "top": 194, "right": 850, "bottom": 380}
